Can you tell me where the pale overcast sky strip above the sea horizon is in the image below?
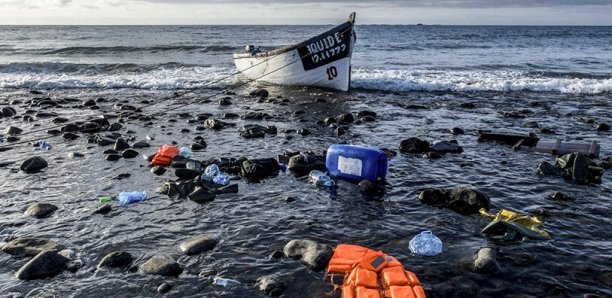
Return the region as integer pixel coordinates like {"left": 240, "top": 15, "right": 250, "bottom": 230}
{"left": 0, "top": 0, "right": 612, "bottom": 26}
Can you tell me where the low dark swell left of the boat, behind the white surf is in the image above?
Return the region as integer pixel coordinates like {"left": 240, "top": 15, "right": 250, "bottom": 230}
{"left": 35, "top": 45, "right": 236, "bottom": 55}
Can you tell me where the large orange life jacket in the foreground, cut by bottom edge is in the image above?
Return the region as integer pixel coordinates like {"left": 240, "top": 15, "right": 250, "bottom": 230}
{"left": 327, "top": 244, "right": 425, "bottom": 298}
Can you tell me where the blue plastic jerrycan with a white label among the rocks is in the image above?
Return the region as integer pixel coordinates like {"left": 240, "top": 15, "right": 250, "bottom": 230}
{"left": 325, "top": 145, "right": 387, "bottom": 182}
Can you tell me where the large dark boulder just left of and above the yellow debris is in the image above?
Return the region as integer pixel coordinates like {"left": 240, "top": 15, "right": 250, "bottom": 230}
{"left": 419, "top": 188, "right": 491, "bottom": 215}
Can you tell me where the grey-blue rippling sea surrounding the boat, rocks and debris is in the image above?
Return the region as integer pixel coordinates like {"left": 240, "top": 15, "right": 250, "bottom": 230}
{"left": 0, "top": 24, "right": 612, "bottom": 298}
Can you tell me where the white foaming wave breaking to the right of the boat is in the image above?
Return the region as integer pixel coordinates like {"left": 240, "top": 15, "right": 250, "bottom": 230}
{"left": 352, "top": 69, "right": 612, "bottom": 94}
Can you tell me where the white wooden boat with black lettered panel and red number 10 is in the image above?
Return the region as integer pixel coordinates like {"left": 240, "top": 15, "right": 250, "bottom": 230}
{"left": 234, "top": 12, "right": 356, "bottom": 91}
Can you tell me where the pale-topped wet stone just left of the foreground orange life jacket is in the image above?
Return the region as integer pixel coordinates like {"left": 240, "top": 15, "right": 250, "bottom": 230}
{"left": 283, "top": 239, "right": 333, "bottom": 271}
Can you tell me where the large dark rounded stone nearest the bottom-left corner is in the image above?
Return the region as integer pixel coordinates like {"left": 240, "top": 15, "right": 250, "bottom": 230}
{"left": 15, "top": 251, "right": 69, "bottom": 280}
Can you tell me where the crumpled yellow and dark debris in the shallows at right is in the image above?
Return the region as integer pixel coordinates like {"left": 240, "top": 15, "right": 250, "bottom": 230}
{"left": 480, "top": 208, "right": 550, "bottom": 241}
